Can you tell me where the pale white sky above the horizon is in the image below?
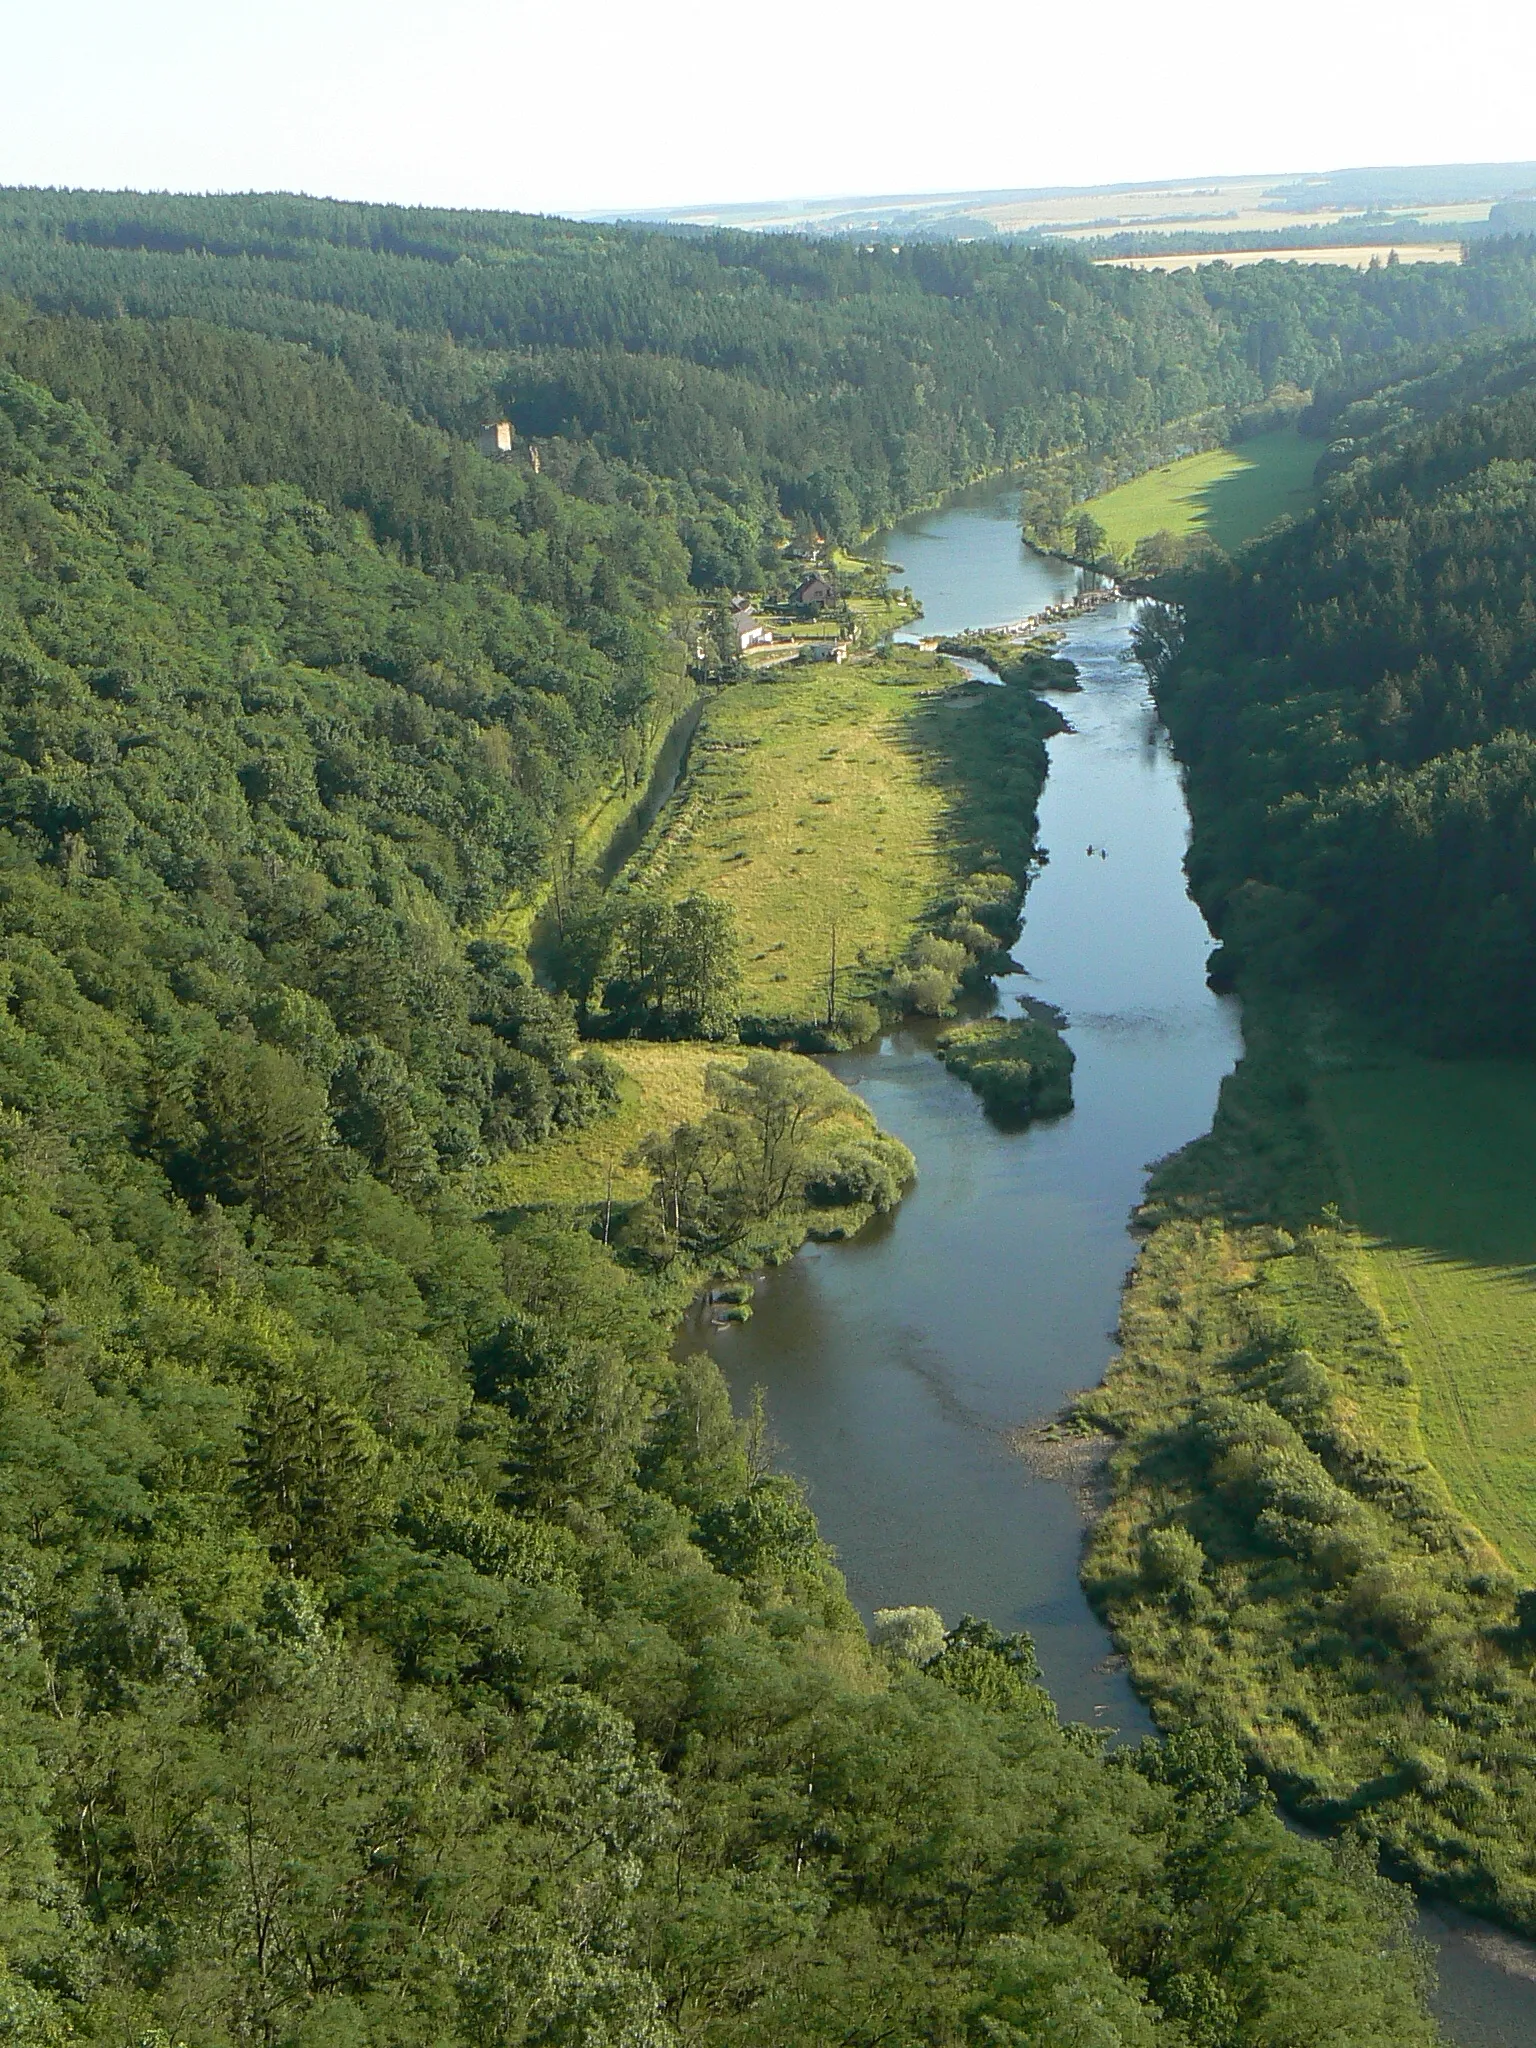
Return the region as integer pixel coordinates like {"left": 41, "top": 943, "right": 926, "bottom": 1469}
{"left": 0, "top": 0, "right": 1536, "bottom": 213}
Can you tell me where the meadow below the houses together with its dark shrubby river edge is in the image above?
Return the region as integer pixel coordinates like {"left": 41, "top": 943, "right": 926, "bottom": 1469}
{"left": 555, "top": 647, "right": 1073, "bottom": 1042}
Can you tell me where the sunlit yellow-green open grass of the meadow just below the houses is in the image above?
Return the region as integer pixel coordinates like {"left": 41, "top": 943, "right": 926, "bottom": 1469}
{"left": 625, "top": 647, "right": 965, "bottom": 1018}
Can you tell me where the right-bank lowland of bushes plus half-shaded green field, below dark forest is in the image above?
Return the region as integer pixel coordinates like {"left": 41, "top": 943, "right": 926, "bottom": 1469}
{"left": 1077, "top": 1015, "right": 1536, "bottom": 1933}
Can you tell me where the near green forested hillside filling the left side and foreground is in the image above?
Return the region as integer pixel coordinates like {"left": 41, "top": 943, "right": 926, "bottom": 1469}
{"left": 0, "top": 280, "right": 1458, "bottom": 2048}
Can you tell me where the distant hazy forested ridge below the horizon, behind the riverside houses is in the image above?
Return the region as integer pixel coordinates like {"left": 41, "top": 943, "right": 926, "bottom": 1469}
{"left": 0, "top": 190, "right": 1536, "bottom": 588}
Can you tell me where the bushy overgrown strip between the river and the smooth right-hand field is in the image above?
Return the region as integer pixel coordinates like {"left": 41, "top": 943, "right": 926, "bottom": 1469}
{"left": 1075, "top": 1001, "right": 1536, "bottom": 1933}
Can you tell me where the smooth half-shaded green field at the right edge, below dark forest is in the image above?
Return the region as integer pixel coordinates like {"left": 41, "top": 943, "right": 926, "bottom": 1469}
{"left": 1317, "top": 1057, "right": 1536, "bottom": 1579}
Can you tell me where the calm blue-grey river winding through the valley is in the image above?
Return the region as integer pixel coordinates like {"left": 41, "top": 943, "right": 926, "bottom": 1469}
{"left": 702, "top": 471, "right": 1536, "bottom": 2048}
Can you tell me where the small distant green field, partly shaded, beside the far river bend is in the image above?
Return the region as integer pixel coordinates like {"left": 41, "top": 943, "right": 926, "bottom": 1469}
{"left": 1085, "top": 428, "right": 1323, "bottom": 561}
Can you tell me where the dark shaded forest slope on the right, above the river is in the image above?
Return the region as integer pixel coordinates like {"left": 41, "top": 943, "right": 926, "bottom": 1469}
{"left": 1143, "top": 344, "right": 1536, "bottom": 1053}
